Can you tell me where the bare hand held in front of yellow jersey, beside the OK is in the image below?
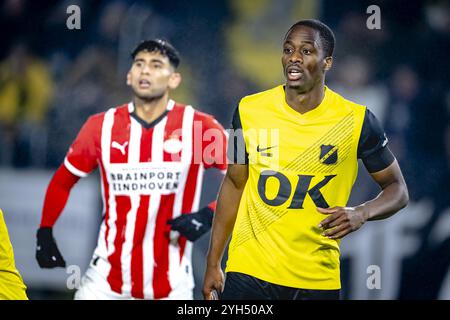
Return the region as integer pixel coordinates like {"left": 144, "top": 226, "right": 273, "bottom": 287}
{"left": 317, "top": 207, "right": 367, "bottom": 239}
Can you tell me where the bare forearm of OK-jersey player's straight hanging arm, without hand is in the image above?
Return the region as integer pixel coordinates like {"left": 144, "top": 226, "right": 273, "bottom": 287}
{"left": 207, "top": 176, "right": 244, "bottom": 267}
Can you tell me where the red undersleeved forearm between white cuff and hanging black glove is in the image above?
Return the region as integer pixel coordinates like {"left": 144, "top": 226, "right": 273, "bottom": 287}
{"left": 40, "top": 165, "right": 80, "bottom": 228}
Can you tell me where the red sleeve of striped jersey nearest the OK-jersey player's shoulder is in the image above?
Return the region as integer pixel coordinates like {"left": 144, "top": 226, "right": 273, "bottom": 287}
{"left": 201, "top": 114, "right": 228, "bottom": 171}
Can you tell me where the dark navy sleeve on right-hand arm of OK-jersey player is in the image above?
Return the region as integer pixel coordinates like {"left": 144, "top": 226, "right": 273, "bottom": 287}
{"left": 358, "top": 109, "right": 395, "bottom": 173}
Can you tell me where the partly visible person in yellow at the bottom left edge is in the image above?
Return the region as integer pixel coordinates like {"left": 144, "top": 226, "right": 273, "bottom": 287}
{"left": 0, "top": 209, "right": 28, "bottom": 300}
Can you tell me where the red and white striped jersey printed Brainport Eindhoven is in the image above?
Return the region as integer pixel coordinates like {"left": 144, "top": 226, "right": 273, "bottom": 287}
{"left": 64, "top": 100, "right": 227, "bottom": 299}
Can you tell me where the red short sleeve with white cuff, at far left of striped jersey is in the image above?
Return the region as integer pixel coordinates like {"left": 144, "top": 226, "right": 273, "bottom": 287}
{"left": 64, "top": 116, "right": 102, "bottom": 178}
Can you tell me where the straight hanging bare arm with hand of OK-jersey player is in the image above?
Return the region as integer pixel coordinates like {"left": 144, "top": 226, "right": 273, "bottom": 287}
{"left": 203, "top": 164, "right": 248, "bottom": 300}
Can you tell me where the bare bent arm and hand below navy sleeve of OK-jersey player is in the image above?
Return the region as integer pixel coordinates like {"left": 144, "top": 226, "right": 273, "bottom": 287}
{"left": 317, "top": 160, "right": 409, "bottom": 239}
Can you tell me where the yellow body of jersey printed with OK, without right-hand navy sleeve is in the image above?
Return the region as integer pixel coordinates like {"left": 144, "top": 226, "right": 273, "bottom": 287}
{"left": 226, "top": 86, "right": 378, "bottom": 290}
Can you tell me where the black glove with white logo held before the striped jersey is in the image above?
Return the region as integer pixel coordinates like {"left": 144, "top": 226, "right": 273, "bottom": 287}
{"left": 167, "top": 207, "right": 214, "bottom": 241}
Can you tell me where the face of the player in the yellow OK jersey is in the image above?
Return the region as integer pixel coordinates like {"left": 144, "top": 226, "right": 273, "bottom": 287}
{"left": 281, "top": 26, "right": 331, "bottom": 92}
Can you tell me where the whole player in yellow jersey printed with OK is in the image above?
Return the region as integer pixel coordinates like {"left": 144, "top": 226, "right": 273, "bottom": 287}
{"left": 203, "top": 20, "right": 408, "bottom": 299}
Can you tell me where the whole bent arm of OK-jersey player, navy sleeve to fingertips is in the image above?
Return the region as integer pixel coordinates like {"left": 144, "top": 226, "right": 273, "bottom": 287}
{"left": 317, "top": 110, "right": 409, "bottom": 239}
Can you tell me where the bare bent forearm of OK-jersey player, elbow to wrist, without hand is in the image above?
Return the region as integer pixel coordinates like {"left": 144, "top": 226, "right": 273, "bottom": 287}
{"left": 356, "top": 181, "right": 409, "bottom": 220}
